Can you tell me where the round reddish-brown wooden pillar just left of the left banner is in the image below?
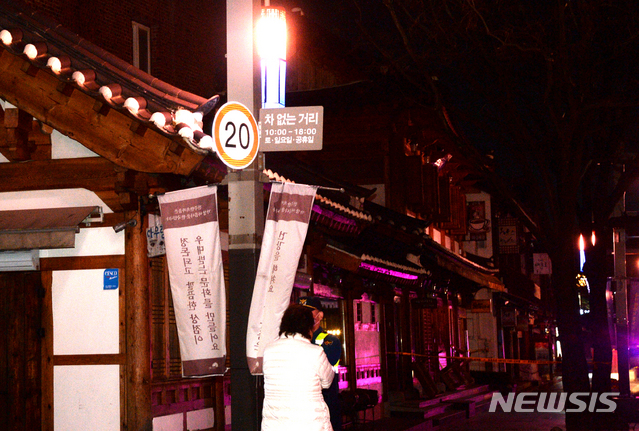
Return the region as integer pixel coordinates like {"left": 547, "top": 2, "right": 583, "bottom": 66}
{"left": 122, "top": 211, "right": 153, "bottom": 431}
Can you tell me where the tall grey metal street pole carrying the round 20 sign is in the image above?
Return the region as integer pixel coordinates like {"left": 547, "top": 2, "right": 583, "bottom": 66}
{"left": 226, "top": 0, "right": 264, "bottom": 431}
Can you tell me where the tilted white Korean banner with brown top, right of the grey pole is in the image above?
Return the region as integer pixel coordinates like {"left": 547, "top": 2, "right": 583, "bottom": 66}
{"left": 246, "top": 183, "right": 317, "bottom": 375}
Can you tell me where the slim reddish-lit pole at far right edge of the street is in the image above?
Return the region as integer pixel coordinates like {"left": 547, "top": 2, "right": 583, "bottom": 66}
{"left": 613, "top": 228, "right": 630, "bottom": 397}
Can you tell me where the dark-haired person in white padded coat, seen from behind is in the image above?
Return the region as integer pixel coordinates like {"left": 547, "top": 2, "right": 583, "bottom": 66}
{"left": 262, "top": 304, "right": 335, "bottom": 431}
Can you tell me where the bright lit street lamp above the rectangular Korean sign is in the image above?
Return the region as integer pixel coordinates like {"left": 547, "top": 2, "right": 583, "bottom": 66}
{"left": 256, "top": 5, "right": 286, "bottom": 108}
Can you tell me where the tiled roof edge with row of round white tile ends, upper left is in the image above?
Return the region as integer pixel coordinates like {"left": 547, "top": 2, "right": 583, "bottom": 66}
{"left": 0, "top": 1, "right": 226, "bottom": 179}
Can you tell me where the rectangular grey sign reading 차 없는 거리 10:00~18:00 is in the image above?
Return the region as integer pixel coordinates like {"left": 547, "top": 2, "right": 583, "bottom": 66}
{"left": 260, "top": 106, "right": 324, "bottom": 152}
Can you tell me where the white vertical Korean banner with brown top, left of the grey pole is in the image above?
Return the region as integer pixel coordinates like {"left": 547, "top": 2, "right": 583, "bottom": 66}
{"left": 158, "top": 186, "right": 226, "bottom": 377}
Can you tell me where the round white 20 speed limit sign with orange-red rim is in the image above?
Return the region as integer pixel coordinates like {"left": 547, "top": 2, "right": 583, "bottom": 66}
{"left": 213, "top": 102, "right": 260, "bottom": 169}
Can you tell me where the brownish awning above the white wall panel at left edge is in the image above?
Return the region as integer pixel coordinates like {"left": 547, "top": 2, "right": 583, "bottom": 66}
{"left": 0, "top": 206, "right": 102, "bottom": 250}
